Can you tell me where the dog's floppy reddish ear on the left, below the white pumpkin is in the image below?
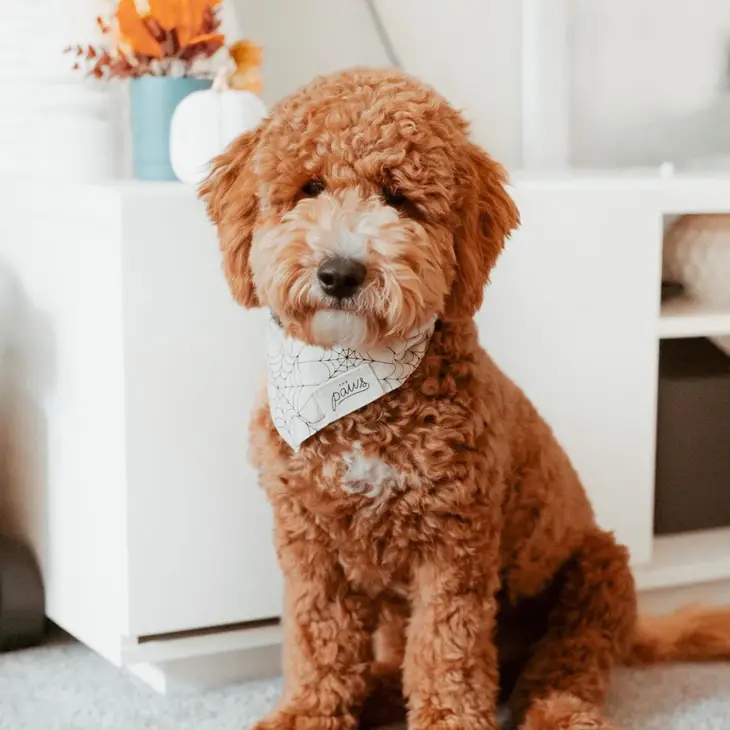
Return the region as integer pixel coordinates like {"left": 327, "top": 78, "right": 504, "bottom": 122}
{"left": 199, "top": 128, "right": 261, "bottom": 307}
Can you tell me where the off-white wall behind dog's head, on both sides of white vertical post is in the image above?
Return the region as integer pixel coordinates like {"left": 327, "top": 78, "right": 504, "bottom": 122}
{"left": 233, "top": 0, "right": 730, "bottom": 166}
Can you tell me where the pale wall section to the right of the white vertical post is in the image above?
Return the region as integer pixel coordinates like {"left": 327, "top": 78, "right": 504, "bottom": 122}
{"left": 571, "top": 0, "right": 730, "bottom": 166}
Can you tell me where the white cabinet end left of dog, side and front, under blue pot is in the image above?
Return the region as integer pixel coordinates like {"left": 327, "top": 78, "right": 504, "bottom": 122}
{"left": 2, "top": 183, "right": 281, "bottom": 684}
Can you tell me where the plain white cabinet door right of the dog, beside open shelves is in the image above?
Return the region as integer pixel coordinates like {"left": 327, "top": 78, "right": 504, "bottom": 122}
{"left": 478, "top": 185, "right": 662, "bottom": 563}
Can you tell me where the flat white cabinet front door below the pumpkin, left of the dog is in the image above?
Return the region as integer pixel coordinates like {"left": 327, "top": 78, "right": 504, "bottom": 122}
{"left": 122, "top": 186, "right": 282, "bottom": 636}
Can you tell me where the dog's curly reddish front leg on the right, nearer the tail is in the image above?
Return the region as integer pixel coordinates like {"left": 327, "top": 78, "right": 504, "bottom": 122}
{"left": 403, "top": 532, "right": 499, "bottom": 730}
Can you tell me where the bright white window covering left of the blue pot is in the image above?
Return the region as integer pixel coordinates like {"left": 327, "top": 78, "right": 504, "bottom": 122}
{"left": 0, "top": 0, "right": 119, "bottom": 180}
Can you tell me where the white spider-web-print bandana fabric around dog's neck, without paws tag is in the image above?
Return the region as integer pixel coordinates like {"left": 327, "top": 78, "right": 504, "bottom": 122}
{"left": 267, "top": 317, "right": 433, "bottom": 447}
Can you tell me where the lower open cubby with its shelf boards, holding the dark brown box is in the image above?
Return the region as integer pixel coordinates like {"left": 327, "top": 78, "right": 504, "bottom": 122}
{"left": 648, "top": 209, "right": 730, "bottom": 590}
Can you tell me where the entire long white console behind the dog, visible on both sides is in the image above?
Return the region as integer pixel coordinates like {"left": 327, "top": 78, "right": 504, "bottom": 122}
{"left": 0, "top": 175, "right": 730, "bottom": 691}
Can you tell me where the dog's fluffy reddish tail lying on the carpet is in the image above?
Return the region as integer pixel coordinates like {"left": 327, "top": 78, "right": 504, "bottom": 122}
{"left": 625, "top": 606, "right": 730, "bottom": 666}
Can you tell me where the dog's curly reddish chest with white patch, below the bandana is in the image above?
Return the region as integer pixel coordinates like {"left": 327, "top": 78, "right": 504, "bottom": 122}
{"left": 258, "top": 390, "right": 484, "bottom": 595}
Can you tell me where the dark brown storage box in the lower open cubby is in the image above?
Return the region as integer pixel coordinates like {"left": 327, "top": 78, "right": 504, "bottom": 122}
{"left": 654, "top": 338, "right": 730, "bottom": 535}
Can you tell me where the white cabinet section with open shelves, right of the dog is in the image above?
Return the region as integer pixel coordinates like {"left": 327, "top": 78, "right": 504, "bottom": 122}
{"left": 477, "top": 171, "right": 730, "bottom": 609}
